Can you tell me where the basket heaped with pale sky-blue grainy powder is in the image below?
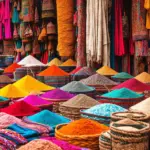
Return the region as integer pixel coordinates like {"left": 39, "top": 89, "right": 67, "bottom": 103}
{"left": 81, "top": 103, "right": 127, "bottom": 125}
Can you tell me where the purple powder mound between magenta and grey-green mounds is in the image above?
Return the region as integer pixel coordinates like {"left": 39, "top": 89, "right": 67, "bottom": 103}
{"left": 41, "top": 89, "right": 75, "bottom": 100}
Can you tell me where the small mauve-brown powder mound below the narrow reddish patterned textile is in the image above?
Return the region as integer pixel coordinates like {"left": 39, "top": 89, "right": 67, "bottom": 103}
{"left": 74, "top": 67, "right": 95, "bottom": 76}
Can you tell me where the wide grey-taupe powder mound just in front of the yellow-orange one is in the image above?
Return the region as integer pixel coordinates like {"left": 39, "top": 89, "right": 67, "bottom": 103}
{"left": 80, "top": 74, "right": 117, "bottom": 85}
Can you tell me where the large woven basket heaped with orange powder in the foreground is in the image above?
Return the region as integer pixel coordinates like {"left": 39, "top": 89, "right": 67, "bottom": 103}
{"left": 55, "top": 119, "right": 109, "bottom": 150}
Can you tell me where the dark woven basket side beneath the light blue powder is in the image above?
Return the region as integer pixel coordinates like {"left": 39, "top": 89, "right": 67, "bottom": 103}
{"left": 80, "top": 110, "right": 110, "bottom": 125}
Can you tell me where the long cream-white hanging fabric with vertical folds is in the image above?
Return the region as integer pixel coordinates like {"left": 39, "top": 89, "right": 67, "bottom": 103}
{"left": 86, "top": 0, "right": 110, "bottom": 66}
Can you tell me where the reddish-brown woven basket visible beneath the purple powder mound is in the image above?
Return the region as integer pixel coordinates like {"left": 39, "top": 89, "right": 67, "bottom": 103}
{"left": 41, "top": 97, "right": 68, "bottom": 113}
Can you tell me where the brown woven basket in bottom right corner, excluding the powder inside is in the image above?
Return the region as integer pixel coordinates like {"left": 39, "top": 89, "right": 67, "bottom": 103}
{"left": 110, "top": 122, "right": 150, "bottom": 150}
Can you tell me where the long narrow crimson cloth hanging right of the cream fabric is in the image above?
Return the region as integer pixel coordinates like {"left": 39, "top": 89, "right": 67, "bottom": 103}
{"left": 115, "top": 0, "right": 125, "bottom": 56}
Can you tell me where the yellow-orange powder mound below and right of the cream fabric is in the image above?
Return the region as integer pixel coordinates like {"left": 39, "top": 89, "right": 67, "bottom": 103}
{"left": 96, "top": 66, "right": 118, "bottom": 76}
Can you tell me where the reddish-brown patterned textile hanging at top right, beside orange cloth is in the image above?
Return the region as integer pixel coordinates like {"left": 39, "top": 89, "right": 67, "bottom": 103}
{"left": 132, "top": 0, "right": 148, "bottom": 41}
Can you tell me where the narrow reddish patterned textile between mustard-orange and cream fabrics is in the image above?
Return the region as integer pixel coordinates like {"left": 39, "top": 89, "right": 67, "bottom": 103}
{"left": 77, "top": 0, "right": 86, "bottom": 67}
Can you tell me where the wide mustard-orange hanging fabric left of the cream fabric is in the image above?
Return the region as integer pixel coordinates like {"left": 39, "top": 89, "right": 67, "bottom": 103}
{"left": 56, "top": 0, "right": 75, "bottom": 57}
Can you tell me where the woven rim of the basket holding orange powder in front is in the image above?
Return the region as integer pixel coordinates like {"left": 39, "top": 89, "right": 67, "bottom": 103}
{"left": 55, "top": 123, "right": 101, "bottom": 138}
